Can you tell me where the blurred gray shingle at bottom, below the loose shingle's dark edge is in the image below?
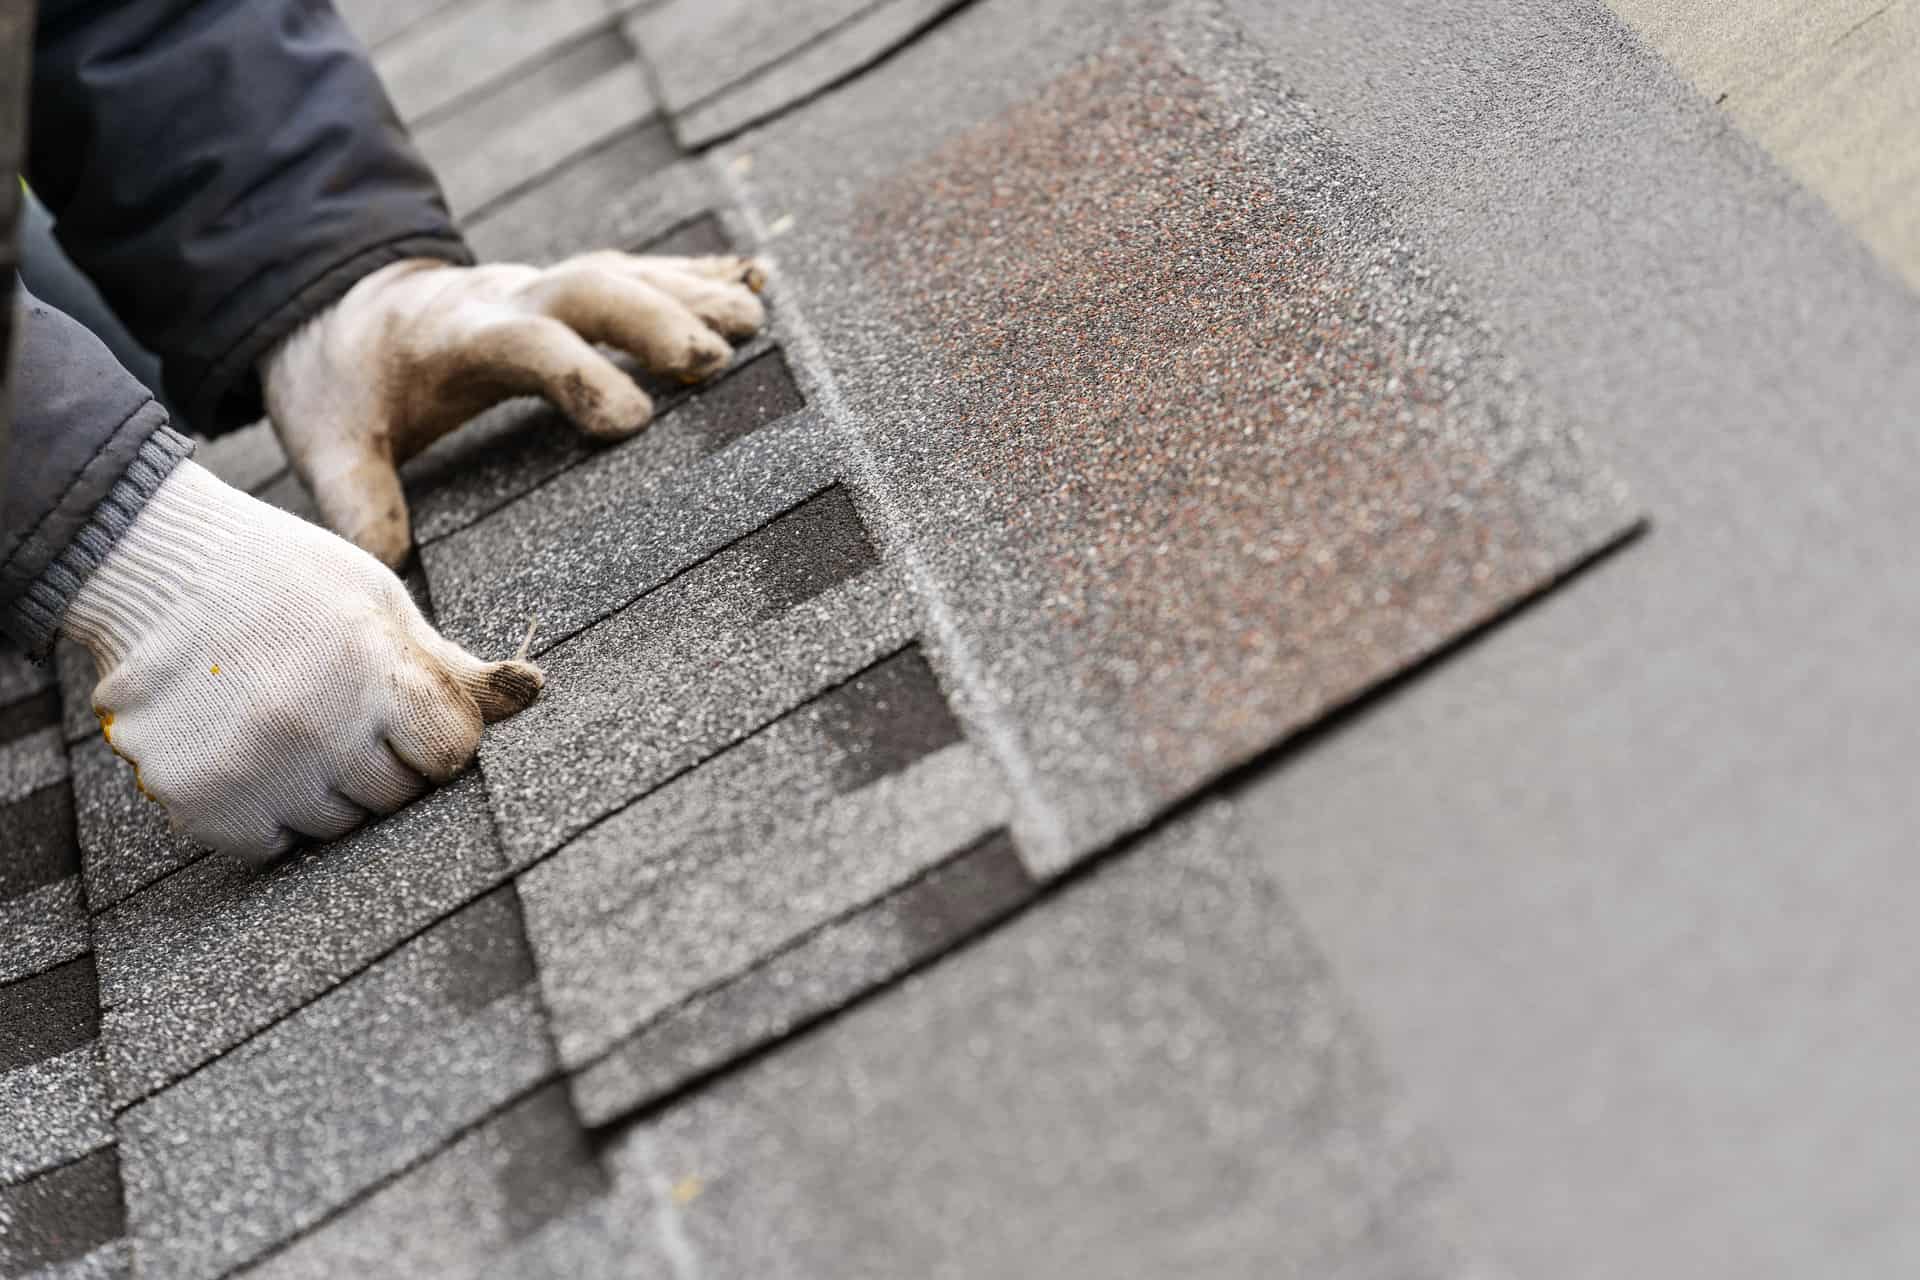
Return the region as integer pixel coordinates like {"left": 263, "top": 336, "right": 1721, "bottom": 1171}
{"left": 607, "top": 806, "right": 1469, "bottom": 1278}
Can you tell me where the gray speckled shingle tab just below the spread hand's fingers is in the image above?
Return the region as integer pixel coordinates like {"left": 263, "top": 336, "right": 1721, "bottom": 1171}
{"left": 420, "top": 357, "right": 814, "bottom": 654}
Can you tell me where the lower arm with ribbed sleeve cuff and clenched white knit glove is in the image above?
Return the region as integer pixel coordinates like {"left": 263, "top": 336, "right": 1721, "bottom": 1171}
{"left": 0, "top": 297, "right": 540, "bottom": 860}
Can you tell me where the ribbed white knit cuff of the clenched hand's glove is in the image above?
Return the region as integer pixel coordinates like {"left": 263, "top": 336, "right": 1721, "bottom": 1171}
{"left": 61, "top": 461, "right": 261, "bottom": 674}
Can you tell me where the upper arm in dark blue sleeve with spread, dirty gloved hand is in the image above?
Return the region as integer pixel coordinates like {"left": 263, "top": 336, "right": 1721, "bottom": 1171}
{"left": 29, "top": 0, "right": 762, "bottom": 564}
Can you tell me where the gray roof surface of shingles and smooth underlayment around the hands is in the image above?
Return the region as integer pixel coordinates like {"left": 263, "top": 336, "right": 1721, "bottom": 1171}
{"left": 0, "top": 0, "right": 1920, "bottom": 1278}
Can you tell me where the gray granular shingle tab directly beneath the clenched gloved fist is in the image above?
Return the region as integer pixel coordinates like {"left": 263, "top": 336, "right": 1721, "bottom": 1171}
{"left": 94, "top": 773, "right": 503, "bottom": 1105}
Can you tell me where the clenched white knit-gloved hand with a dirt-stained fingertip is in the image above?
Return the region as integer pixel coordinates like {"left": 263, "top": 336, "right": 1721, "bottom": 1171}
{"left": 61, "top": 462, "right": 541, "bottom": 862}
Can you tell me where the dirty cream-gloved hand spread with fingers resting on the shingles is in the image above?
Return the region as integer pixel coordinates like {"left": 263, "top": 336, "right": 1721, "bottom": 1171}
{"left": 261, "top": 251, "right": 766, "bottom": 566}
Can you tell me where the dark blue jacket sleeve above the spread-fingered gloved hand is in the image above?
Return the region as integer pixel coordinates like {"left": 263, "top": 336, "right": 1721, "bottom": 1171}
{"left": 27, "top": 0, "right": 472, "bottom": 432}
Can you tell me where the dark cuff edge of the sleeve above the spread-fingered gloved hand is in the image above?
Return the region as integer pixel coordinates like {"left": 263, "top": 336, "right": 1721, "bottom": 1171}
{"left": 177, "top": 232, "right": 474, "bottom": 436}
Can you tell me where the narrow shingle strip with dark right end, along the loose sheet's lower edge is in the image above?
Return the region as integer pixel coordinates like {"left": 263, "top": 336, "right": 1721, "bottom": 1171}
{"left": 570, "top": 833, "right": 1035, "bottom": 1125}
